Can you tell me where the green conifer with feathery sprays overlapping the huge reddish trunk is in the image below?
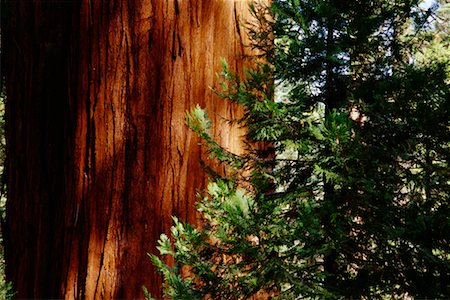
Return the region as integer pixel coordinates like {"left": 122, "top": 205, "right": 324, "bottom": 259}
{"left": 152, "top": 0, "right": 450, "bottom": 299}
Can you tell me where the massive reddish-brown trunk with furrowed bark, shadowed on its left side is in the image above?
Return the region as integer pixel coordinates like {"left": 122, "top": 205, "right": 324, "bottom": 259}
{"left": 2, "top": 0, "right": 253, "bottom": 299}
